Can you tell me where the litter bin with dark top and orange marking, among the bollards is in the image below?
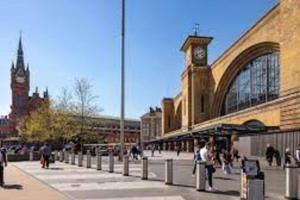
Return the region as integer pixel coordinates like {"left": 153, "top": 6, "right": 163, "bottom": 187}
{"left": 241, "top": 159, "right": 265, "bottom": 200}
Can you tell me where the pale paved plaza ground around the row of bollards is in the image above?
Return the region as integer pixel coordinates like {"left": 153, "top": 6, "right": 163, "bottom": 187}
{"left": 0, "top": 152, "right": 300, "bottom": 200}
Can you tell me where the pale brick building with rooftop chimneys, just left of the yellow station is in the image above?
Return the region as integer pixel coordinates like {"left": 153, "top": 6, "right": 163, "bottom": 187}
{"left": 141, "top": 107, "right": 161, "bottom": 145}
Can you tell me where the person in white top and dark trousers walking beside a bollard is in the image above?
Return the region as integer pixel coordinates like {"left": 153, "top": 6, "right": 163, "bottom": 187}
{"left": 200, "top": 142, "right": 216, "bottom": 192}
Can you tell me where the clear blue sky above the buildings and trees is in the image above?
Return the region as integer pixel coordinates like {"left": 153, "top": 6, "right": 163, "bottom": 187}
{"left": 0, "top": 0, "right": 277, "bottom": 118}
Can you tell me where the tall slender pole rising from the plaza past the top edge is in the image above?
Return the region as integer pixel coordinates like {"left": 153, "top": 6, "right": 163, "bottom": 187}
{"left": 120, "top": 0, "right": 125, "bottom": 161}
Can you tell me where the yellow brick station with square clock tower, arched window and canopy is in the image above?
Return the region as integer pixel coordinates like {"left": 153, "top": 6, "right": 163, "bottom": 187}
{"left": 152, "top": 0, "right": 300, "bottom": 155}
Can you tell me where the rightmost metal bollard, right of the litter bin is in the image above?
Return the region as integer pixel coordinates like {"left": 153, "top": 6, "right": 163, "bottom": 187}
{"left": 285, "top": 164, "right": 298, "bottom": 200}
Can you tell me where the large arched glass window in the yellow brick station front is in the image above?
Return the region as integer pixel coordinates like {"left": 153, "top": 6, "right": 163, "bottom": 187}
{"left": 222, "top": 52, "right": 280, "bottom": 115}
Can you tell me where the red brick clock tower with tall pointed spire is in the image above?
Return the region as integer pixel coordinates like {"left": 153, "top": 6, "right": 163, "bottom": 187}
{"left": 10, "top": 36, "right": 30, "bottom": 130}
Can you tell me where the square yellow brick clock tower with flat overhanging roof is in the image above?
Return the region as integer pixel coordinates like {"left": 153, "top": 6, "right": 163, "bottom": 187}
{"left": 181, "top": 33, "right": 213, "bottom": 129}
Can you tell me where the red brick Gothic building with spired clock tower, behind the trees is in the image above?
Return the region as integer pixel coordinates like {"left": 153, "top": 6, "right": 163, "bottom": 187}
{"left": 0, "top": 37, "right": 49, "bottom": 138}
